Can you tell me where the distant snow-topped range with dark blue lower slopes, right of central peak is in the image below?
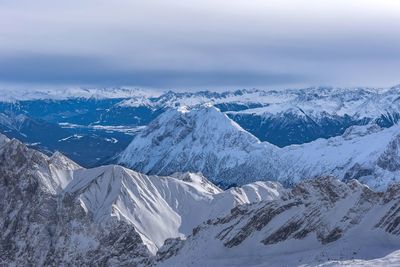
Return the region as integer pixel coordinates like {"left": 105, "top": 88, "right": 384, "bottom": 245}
{"left": 227, "top": 87, "right": 400, "bottom": 147}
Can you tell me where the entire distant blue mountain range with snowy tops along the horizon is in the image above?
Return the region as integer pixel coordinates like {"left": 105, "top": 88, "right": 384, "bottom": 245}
{"left": 0, "top": 86, "right": 400, "bottom": 176}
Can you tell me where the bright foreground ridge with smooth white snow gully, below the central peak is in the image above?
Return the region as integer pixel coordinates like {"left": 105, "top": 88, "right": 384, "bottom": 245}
{"left": 65, "top": 168, "right": 284, "bottom": 253}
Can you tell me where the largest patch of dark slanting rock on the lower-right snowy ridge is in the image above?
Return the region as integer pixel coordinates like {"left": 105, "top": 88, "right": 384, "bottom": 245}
{"left": 212, "top": 177, "right": 372, "bottom": 247}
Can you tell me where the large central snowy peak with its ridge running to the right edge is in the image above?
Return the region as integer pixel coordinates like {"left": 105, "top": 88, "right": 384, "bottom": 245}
{"left": 119, "top": 106, "right": 400, "bottom": 188}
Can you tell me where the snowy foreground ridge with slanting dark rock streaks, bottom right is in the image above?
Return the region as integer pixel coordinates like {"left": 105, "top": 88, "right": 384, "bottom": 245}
{"left": 157, "top": 177, "right": 400, "bottom": 267}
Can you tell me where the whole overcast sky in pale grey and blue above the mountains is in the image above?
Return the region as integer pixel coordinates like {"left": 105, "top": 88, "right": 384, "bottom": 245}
{"left": 0, "top": 0, "right": 400, "bottom": 89}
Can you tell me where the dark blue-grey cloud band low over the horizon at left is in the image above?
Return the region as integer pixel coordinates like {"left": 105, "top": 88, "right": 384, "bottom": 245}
{"left": 0, "top": 54, "right": 306, "bottom": 89}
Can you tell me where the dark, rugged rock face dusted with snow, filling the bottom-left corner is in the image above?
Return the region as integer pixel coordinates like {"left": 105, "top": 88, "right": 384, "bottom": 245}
{"left": 0, "top": 140, "right": 150, "bottom": 266}
